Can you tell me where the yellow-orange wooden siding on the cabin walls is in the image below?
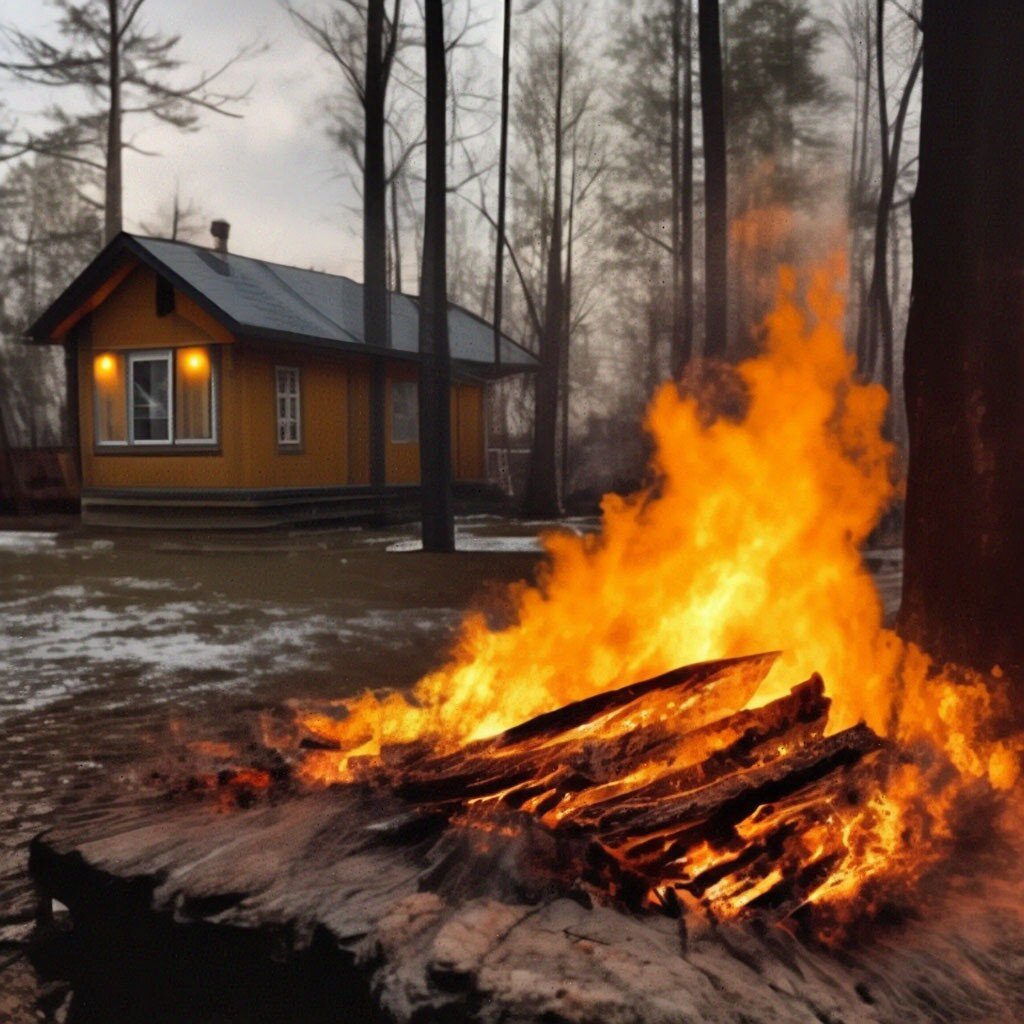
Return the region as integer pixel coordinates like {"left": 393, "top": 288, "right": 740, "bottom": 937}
{"left": 78, "top": 266, "right": 484, "bottom": 490}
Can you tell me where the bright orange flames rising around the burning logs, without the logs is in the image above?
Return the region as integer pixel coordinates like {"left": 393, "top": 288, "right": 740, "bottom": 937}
{"left": 305, "top": 251, "right": 1019, "bottom": 912}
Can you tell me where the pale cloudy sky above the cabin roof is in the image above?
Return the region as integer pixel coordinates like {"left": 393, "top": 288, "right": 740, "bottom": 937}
{"left": 0, "top": 0, "right": 500, "bottom": 278}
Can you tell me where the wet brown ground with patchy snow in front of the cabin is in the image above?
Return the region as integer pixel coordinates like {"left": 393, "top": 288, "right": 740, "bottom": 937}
{"left": 0, "top": 517, "right": 900, "bottom": 1024}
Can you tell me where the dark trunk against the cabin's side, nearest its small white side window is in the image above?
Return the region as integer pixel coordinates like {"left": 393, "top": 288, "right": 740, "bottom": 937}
{"left": 362, "top": 0, "right": 388, "bottom": 488}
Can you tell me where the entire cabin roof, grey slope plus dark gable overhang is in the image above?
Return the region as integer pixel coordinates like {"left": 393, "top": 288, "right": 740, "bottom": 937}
{"left": 28, "top": 233, "right": 537, "bottom": 372}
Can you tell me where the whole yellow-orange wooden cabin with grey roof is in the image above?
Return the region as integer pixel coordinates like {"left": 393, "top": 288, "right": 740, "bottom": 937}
{"left": 30, "top": 234, "right": 536, "bottom": 526}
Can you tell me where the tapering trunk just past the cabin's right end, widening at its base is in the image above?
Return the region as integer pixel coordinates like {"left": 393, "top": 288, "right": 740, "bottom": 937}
{"left": 524, "top": 33, "right": 565, "bottom": 517}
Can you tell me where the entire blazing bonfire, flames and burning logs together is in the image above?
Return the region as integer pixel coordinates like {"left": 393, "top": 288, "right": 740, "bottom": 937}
{"left": 303, "top": 260, "right": 1019, "bottom": 918}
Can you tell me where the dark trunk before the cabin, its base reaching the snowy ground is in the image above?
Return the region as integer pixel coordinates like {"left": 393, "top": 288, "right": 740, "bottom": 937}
{"left": 420, "top": 0, "right": 455, "bottom": 551}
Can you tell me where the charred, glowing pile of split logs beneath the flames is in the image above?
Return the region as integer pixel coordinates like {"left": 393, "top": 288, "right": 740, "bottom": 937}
{"left": 333, "top": 653, "right": 883, "bottom": 915}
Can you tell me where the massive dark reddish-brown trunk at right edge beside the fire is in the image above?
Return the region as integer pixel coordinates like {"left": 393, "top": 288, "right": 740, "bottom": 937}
{"left": 901, "top": 0, "right": 1024, "bottom": 679}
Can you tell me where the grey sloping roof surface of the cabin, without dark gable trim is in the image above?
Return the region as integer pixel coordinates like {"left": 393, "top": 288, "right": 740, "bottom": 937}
{"left": 131, "top": 236, "right": 537, "bottom": 369}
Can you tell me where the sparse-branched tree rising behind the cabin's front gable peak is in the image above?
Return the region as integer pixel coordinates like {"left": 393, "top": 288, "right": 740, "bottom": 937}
{"left": 0, "top": 0, "right": 254, "bottom": 241}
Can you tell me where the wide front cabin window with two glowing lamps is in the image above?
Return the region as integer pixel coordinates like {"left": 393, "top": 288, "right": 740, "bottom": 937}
{"left": 92, "top": 346, "right": 218, "bottom": 445}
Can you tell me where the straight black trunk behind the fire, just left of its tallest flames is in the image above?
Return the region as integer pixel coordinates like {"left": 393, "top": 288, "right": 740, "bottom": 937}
{"left": 697, "top": 0, "right": 729, "bottom": 359}
